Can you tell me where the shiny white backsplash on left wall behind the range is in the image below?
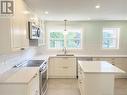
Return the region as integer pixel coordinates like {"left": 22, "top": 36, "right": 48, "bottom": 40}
{"left": 0, "top": 48, "right": 36, "bottom": 74}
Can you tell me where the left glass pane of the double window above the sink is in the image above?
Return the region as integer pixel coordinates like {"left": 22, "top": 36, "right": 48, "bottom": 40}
{"left": 50, "top": 32, "right": 64, "bottom": 48}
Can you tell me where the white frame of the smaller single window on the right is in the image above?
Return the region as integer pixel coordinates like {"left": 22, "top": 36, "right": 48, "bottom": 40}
{"left": 101, "top": 27, "right": 121, "bottom": 50}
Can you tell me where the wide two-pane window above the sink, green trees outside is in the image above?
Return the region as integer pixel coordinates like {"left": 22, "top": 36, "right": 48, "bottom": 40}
{"left": 48, "top": 31, "right": 82, "bottom": 49}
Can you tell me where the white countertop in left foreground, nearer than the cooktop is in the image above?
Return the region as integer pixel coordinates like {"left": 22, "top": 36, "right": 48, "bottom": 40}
{"left": 0, "top": 67, "right": 39, "bottom": 83}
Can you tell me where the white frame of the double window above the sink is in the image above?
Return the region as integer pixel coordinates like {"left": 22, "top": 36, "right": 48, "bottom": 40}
{"left": 47, "top": 30, "right": 83, "bottom": 50}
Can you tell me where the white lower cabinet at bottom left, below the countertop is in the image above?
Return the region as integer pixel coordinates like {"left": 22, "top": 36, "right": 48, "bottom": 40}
{"left": 0, "top": 74, "right": 40, "bottom": 95}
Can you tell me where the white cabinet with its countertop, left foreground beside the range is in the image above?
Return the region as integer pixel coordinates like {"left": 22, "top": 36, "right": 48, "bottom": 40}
{"left": 0, "top": 67, "right": 40, "bottom": 95}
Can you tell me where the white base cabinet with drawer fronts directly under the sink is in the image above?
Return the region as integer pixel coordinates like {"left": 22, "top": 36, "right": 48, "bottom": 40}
{"left": 48, "top": 57, "right": 76, "bottom": 78}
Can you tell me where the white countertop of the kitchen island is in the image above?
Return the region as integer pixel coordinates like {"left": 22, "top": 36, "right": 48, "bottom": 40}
{"left": 78, "top": 61, "right": 125, "bottom": 74}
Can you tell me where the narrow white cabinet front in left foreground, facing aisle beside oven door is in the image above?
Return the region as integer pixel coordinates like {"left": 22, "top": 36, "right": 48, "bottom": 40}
{"left": 27, "top": 74, "right": 39, "bottom": 95}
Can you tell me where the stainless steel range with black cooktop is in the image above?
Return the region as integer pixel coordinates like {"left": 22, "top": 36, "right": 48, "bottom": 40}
{"left": 14, "top": 60, "right": 48, "bottom": 95}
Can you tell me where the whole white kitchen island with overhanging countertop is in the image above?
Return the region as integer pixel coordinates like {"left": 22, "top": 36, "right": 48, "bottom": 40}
{"left": 78, "top": 61, "right": 125, "bottom": 95}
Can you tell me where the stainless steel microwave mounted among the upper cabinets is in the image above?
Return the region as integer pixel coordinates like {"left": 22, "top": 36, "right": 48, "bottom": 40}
{"left": 28, "top": 22, "right": 41, "bottom": 39}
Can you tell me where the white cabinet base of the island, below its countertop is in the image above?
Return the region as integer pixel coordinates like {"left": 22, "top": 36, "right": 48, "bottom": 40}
{"left": 78, "top": 63, "right": 114, "bottom": 95}
